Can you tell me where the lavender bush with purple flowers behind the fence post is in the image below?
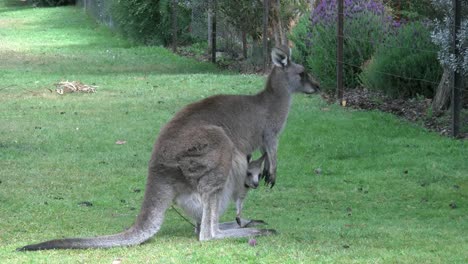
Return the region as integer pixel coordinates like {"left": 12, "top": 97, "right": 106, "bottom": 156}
{"left": 290, "top": 0, "right": 391, "bottom": 91}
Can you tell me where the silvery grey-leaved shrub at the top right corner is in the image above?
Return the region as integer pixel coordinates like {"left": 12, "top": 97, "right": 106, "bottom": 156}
{"left": 432, "top": 0, "right": 468, "bottom": 76}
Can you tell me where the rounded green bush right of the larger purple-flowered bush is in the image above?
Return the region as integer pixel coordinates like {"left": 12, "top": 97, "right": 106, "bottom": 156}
{"left": 360, "top": 22, "right": 442, "bottom": 97}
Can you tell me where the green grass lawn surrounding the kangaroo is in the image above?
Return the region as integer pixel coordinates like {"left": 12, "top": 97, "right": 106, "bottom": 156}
{"left": 0, "top": 0, "right": 468, "bottom": 263}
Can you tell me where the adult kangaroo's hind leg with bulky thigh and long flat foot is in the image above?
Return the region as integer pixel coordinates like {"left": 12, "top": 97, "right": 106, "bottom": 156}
{"left": 177, "top": 126, "right": 274, "bottom": 241}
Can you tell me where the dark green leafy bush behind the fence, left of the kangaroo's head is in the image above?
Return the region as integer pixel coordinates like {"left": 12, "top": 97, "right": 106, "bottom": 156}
{"left": 111, "top": 0, "right": 191, "bottom": 45}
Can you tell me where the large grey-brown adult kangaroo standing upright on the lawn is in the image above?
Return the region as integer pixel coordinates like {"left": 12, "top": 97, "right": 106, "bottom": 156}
{"left": 18, "top": 47, "right": 318, "bottom": 251}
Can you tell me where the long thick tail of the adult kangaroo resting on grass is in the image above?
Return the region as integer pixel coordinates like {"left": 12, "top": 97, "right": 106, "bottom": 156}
{"left": 17, "top": 176, "right": 174, "bottom": 251}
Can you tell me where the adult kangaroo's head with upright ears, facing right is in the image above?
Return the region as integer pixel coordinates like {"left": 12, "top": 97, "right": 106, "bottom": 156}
{"left": 271, "top": 46, "right": 320, "bottom": 94}
